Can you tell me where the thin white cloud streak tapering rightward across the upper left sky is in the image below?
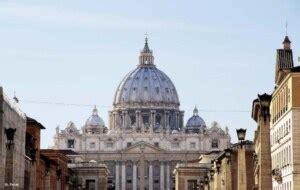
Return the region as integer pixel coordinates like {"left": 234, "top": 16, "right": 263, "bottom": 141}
{"left": 0, "top": 2, "right": 203, "bottom": 31}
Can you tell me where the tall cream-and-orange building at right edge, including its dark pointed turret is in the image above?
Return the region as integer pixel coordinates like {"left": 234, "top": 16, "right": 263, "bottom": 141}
{"left": 270, "top": 36, "right": 300, "bottom": 190}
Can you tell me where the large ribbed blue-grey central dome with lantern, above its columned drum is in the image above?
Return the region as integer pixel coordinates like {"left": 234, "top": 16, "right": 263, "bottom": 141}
{"left": 113, "top": 38, "right": 180, "bottom": 108}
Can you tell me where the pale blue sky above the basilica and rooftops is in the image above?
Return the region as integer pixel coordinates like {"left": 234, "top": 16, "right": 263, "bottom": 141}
{"left": 0, "top": 0, "right": 300, "bottom": 148}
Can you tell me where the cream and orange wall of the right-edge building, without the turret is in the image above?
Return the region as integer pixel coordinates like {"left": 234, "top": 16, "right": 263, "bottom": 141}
{"left": 270, "top": 73, "right": 300, "bottom": 190}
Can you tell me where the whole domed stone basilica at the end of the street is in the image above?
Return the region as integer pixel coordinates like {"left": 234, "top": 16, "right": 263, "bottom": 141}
{"left": 54, "top": 38, "right": 230, "bottom": 190}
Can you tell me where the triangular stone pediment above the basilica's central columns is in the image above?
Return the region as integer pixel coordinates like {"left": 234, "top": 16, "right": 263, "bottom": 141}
{"left": 121, "top": 141, "right": 165, "bottom": 154}
